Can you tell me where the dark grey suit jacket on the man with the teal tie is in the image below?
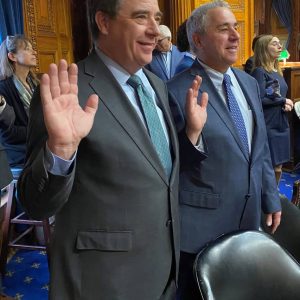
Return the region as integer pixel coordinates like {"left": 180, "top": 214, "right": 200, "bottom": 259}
{"left": 19, "top": 52, "right": 179, "bottom": 300}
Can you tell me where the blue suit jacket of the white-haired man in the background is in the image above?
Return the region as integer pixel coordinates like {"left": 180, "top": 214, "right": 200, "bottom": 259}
{"left": 146, "top": 45, "right": 185, "bottom": 81}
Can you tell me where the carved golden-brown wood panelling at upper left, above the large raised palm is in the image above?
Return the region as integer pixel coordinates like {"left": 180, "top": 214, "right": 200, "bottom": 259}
{"left": 23, "top": 0, "right": 73, "bottom": 73}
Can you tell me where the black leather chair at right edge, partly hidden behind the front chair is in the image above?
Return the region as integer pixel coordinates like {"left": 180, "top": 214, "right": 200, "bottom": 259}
{"left": 261, "top": 196, "right": 300, "bottom": 262}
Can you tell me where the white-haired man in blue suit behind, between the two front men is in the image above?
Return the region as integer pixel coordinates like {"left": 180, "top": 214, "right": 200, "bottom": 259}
{"left": 146, "top": 25, "right": 185, "bottom": 81}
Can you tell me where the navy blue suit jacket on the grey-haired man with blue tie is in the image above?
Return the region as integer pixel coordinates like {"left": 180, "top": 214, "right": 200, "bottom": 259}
{"left": 168, "top": 61, "right": 281, "bottom": 253}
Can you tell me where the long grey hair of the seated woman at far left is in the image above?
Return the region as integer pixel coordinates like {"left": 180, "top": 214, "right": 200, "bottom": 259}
{"left": 0, "top": 35, "right": 31, "bottom": 80}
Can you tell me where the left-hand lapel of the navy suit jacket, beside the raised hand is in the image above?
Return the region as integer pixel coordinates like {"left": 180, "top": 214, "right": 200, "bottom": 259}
{"left": 191, "top": 60, "right": 249, "bottom": 161}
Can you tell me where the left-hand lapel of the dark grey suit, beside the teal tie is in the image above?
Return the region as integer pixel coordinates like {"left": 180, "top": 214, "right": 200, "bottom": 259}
{"left": 85, "top": 53, "right": 169, "bottom": 184}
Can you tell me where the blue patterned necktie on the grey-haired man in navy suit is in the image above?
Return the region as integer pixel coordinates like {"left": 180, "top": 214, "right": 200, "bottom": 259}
{"left": 223, "top": 74, "right": 249, "bottom": 154}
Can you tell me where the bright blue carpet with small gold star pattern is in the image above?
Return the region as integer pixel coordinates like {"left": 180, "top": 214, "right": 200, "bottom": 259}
{"left": 3, "top": 172, "right": 300, "bottom": 300}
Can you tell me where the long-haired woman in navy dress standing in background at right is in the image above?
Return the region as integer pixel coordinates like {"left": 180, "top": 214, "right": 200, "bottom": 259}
{"left": 251, "top": 35, "right": 293, "bottom": 184}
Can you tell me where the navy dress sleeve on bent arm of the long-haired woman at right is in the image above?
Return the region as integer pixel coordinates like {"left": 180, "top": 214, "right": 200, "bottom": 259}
{"left": 251, "top": 68, "right": 286, "bottom": 107}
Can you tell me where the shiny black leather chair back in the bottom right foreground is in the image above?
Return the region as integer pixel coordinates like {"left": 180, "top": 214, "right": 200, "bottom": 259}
{"left": 194, "top": 231, "right": 300, "bottom": 300}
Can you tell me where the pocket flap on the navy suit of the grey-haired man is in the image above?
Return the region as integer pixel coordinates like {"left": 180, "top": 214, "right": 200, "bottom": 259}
{"left": 179, "top": 190, "right": 220, "bottom": 209}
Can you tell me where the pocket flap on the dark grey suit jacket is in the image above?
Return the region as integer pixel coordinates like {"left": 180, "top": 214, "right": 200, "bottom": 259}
{"left": 76, "top": 230, "right": 132, "bottom": 251}
